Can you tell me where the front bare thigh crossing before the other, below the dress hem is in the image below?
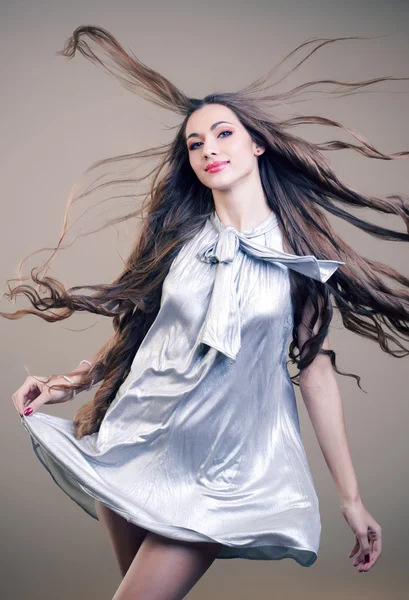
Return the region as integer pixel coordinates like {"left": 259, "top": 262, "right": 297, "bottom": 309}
{"left": 112, "top": 531, "right": 222, "bottom": 600}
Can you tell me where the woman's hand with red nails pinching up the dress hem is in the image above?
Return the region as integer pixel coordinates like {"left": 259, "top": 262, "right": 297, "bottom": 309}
{"left": 12, "top": 375, "right": 77, "bottom": 417}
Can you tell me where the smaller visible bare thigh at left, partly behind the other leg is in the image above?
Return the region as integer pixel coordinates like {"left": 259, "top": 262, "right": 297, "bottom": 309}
{"left": 95, "top": 500, "right": 146, "bottom": 577}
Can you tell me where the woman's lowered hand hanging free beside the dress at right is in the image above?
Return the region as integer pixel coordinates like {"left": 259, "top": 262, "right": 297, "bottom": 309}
{"left": 341, "top": 500, "right": 382, "bottom": 572}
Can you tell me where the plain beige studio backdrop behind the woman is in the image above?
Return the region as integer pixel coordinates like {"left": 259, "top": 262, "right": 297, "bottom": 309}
{"left": 0, "top": 0, "right": 409, "bottom": 600}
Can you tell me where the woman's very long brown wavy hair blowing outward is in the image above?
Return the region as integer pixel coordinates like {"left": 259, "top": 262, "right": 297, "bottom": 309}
{"left": 0, "top": 26, "right": 409, "bottom": 439}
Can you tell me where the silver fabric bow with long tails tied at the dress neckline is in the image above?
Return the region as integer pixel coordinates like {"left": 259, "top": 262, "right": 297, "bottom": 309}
{"left": 197, "top": 211, "right": 345, "bottom": 362}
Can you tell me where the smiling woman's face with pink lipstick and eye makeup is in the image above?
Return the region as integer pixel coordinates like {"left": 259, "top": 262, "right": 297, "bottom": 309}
{"left": 185, "top": 104, "right": 264, "bottom": 190}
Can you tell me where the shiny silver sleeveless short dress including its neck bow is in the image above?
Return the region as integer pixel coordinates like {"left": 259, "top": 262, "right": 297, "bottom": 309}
{"left": 21, "top": 211, "right": 344, "bottom": 567}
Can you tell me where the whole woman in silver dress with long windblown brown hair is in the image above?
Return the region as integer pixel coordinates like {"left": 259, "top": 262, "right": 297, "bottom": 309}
{"left": 7, "top": 26, "right": 409, "bottom": 600}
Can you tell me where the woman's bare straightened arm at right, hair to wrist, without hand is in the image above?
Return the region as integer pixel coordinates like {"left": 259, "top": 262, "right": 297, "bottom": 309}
{"left": 298, "top": 296, "right": 361, "bottom": 507}
